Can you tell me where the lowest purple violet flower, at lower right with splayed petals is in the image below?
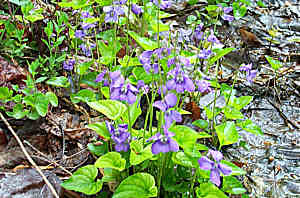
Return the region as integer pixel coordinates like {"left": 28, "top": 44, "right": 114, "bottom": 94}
{"left": 198, "top": 150, "right": 232, "bottom": 186}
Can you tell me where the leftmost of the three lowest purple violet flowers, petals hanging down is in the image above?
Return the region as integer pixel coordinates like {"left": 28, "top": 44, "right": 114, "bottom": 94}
{"left": 105, "top": 121, "right": 130, "bottom": 152}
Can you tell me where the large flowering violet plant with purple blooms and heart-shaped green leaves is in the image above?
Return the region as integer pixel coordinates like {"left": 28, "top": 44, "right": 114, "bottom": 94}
{"left": 29, "top": 0, "right": 261, "bottom": 198}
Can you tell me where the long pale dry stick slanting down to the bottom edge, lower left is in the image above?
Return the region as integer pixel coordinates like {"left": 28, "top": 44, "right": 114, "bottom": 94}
{"left": 0, "top": 112, "right": 59, "bottom": 198}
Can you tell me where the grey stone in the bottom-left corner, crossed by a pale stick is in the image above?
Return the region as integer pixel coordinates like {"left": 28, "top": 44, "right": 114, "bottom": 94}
{"left": 0, "top": 169, "right": 62, "bottom": 198}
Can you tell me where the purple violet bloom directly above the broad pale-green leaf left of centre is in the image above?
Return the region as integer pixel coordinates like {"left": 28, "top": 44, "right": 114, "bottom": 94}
{"left": 109, "top": 71, "right": 139, "bottom": 105}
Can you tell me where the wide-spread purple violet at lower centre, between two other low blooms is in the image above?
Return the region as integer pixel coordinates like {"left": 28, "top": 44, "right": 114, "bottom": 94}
{"left": 147, "top": 127, "right": 179, "bottom": 155}
